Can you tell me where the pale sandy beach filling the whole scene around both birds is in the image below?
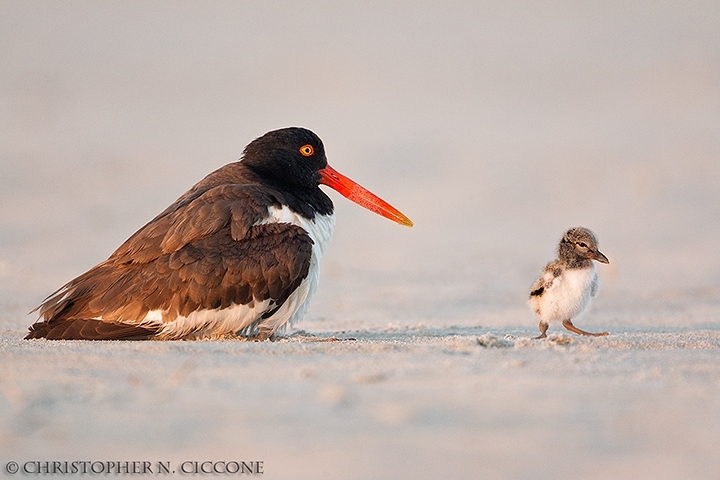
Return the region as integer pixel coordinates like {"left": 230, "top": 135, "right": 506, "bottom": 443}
{"left": 0, "top": 1, "right": 720, "bottom": 479}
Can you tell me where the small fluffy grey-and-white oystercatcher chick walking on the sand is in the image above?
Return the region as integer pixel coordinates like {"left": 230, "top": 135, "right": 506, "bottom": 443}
{"left": 530, "top": 227, "right": 610, "bottom": 338}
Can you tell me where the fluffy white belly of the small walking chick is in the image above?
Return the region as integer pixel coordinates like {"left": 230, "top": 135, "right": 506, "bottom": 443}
{"left": 537, "top": 266, "right": 597, "bottom": 323}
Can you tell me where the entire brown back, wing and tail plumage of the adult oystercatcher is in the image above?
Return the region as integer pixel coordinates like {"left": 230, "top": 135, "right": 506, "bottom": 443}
{"left": 27, "top": 178, "right": 312, "bottom": 339}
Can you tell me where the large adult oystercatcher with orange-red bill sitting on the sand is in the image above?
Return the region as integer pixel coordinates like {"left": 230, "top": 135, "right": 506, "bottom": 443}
{"left": 25, "top": 127, "right": 412, "bottom": 340}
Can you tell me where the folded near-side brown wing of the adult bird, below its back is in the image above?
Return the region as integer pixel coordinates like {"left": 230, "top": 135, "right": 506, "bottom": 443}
{"left": 28, "top": 223, "right": 313, "bottom": 338}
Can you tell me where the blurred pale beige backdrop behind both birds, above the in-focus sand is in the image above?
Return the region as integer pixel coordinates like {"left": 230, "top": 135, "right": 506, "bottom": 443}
{"left": 0, "top": 0, "right": 720, "bottom": 334}
